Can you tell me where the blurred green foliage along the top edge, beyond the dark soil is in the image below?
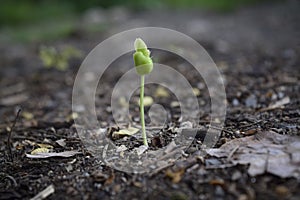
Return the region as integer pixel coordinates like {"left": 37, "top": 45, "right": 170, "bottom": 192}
{"left": 0, "top": 0, "right": 274, "bottom": 43}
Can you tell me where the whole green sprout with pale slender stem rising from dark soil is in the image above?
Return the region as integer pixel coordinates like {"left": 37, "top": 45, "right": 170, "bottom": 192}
{"left": 133, "top": 38, "right": 153, "bottom": 146}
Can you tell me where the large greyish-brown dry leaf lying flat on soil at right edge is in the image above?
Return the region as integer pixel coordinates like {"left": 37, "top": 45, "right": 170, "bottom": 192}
{"left": 207, "top": 132, "right": 300, "bottom": 178}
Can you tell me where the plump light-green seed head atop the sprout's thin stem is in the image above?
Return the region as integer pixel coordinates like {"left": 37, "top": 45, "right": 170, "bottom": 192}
{"left": 133, "top": 38, "right": 153, "bottom": 75}
